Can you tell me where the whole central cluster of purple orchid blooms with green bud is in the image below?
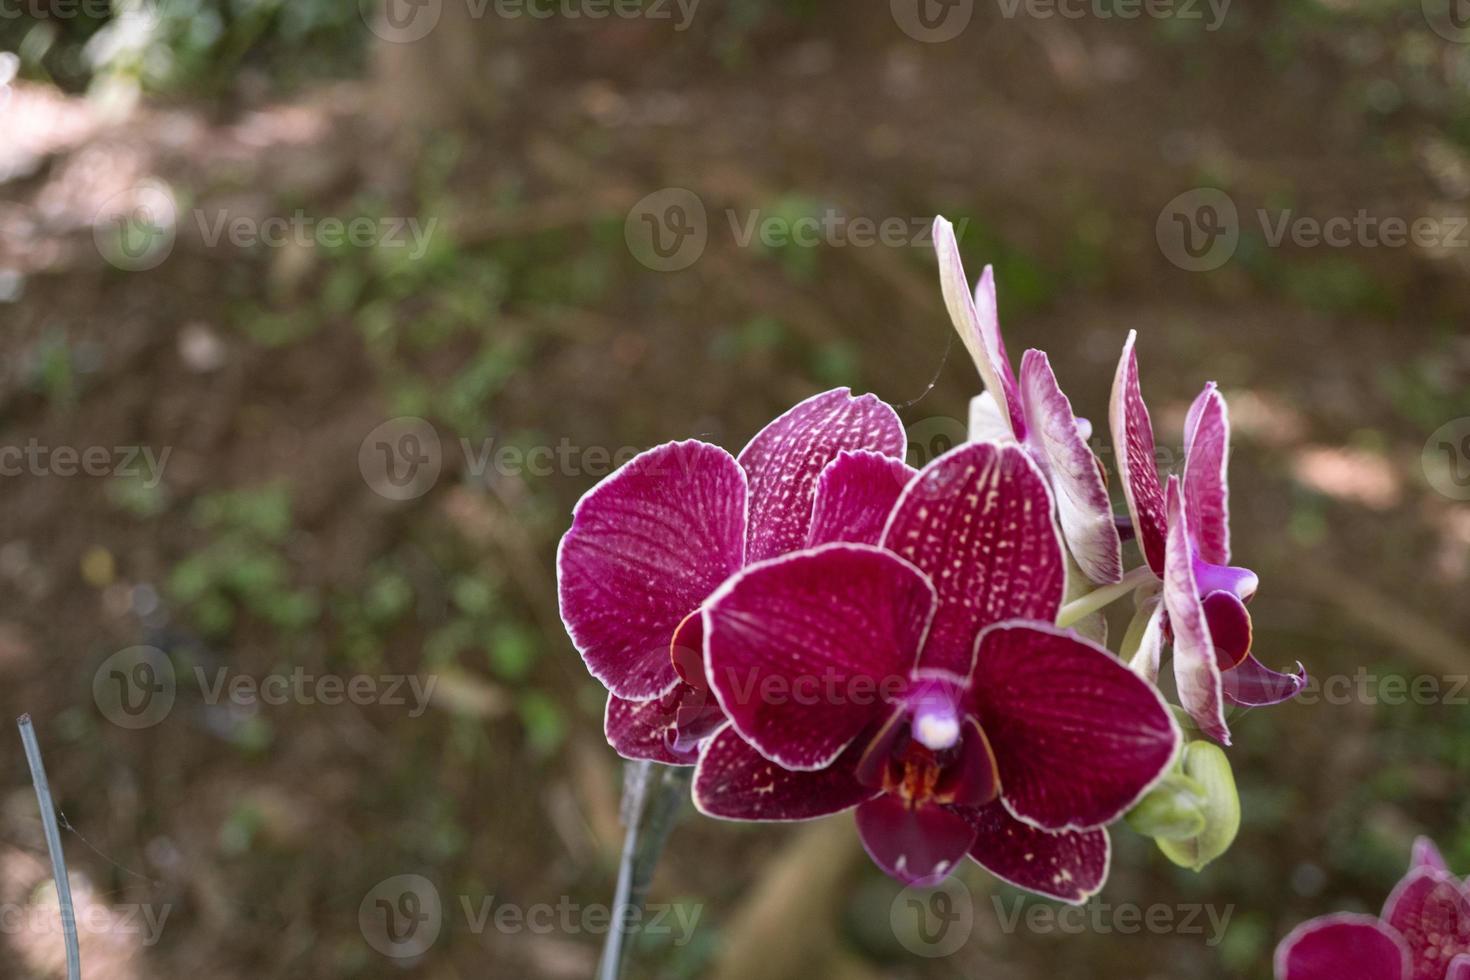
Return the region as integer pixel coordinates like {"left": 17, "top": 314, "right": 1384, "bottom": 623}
{"left": 557, "top": 217, "right": 1305, "bottom": 902}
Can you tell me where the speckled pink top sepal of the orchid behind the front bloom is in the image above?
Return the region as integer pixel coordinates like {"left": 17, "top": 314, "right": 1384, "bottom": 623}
{"left": 739, "top": 388, "right": 907, "bottom": 561}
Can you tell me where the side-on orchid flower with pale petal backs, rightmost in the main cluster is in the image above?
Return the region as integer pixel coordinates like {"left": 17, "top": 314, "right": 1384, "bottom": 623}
{"left": 1108, "top": 331, "right": 1307, "bottom": 745}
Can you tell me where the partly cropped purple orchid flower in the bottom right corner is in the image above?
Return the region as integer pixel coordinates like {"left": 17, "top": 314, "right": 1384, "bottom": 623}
{"left": 1276, "top": 837, "right": 1470, "bottom": 980}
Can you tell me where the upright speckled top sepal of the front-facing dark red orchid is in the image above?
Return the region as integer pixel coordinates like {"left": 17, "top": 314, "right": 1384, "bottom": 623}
{"left": 883, "top": 442, "right": 1066, "bottom": 676}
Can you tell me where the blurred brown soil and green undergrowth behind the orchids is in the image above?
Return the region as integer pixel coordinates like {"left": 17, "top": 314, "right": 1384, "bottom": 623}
{"left": 0, "top": 0, "right": 1470, "bottom": 980}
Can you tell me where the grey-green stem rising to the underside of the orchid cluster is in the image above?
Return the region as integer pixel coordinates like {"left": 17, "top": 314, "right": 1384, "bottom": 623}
{"left": 597, "top": 761, "right": 694, "bottom": 980}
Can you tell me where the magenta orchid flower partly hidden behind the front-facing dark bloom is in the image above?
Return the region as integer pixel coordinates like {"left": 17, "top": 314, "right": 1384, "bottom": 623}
{"left": 557, "top": 388, "right": 914, "bottom": 765}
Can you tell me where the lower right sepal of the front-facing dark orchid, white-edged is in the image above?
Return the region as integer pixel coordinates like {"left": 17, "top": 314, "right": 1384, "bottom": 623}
{"left": 960, "top": 804, "right": 1113, "bottom": 905}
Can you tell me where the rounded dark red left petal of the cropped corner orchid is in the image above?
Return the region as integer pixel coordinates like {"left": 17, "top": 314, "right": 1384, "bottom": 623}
{"left": 1276, "top": 914, "right": 1411, "bottom": 980}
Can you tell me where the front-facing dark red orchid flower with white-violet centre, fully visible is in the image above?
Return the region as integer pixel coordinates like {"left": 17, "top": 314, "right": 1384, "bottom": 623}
{"left": 694, "top": 442, "right": 1180, "bottom": 902}
